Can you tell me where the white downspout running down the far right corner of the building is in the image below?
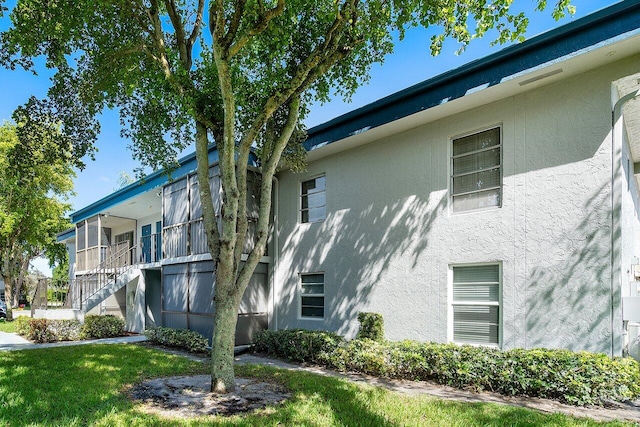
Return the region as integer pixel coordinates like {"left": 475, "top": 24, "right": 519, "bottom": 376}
{"left": 609, "top": 89, "right": 640, "bottom": 357}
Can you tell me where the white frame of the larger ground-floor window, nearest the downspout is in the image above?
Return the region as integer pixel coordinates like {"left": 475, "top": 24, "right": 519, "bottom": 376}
{"left": 447, "top": 261, "right": 504, "bottom": 348}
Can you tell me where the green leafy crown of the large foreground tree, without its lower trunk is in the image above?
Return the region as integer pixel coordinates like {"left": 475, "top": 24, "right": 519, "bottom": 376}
{"left": 0, "top": 0, "right": 574, "bottom": 171}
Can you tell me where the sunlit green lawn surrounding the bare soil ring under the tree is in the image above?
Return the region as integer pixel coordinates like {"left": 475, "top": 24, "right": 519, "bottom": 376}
{"left": 0, "top": 345, "right": 624, "bottom": 427}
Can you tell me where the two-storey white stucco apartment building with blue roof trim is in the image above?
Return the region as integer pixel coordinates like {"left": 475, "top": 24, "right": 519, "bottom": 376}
{"left": 53, "top": 1, "right": 640, "bottom": 357}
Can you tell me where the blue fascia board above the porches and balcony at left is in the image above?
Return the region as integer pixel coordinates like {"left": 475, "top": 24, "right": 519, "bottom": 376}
{"left": 71, "top": 145, "right": 218, "bottom": 224}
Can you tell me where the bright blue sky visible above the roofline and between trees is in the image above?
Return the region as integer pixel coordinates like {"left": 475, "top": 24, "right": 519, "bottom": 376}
{"left": 0, "top": 0, "right": 616, "bottom": 270}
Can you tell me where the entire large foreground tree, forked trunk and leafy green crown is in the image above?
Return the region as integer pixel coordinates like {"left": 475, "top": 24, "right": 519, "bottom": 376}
{"left": 0, "top": 0, "right": 571, "bottom": 391}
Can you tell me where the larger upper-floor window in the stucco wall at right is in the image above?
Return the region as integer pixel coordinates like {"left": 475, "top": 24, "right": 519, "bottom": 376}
{"left": 451, "top": 128, "right": 502, "bottom": 212}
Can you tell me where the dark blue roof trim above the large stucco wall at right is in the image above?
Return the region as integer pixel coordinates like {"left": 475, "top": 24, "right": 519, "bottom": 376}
{"left": 304, "top": 0, "right": 640, "bottom": 151}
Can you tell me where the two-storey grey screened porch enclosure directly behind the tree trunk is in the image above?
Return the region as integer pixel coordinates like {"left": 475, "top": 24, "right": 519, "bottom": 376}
{"left": 160, "top": 164, "right": 269, "bottom": 345}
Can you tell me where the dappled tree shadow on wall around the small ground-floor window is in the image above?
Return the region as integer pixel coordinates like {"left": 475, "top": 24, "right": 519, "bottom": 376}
{"left": 278, "top": 191, "right": 447, "bottom": 335}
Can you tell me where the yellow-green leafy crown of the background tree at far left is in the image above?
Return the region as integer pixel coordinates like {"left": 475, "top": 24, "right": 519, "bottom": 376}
{"left": 0, "top": 108, "right": 75, "bottom": 316}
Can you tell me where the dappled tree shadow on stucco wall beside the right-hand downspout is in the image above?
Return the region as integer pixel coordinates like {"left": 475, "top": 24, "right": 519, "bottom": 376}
{"left": 525, "top": 182, "right": 620, "bottom": 353}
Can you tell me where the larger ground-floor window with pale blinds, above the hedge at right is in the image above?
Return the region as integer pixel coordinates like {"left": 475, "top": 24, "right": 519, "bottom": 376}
{"left": 452, "top": 264, "right": 501, "bottom": 345}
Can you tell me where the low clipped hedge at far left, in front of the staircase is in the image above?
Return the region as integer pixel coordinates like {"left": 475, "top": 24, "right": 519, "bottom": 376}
{"left": 15, "top": 315, "right": 124, "bottom": 343}
